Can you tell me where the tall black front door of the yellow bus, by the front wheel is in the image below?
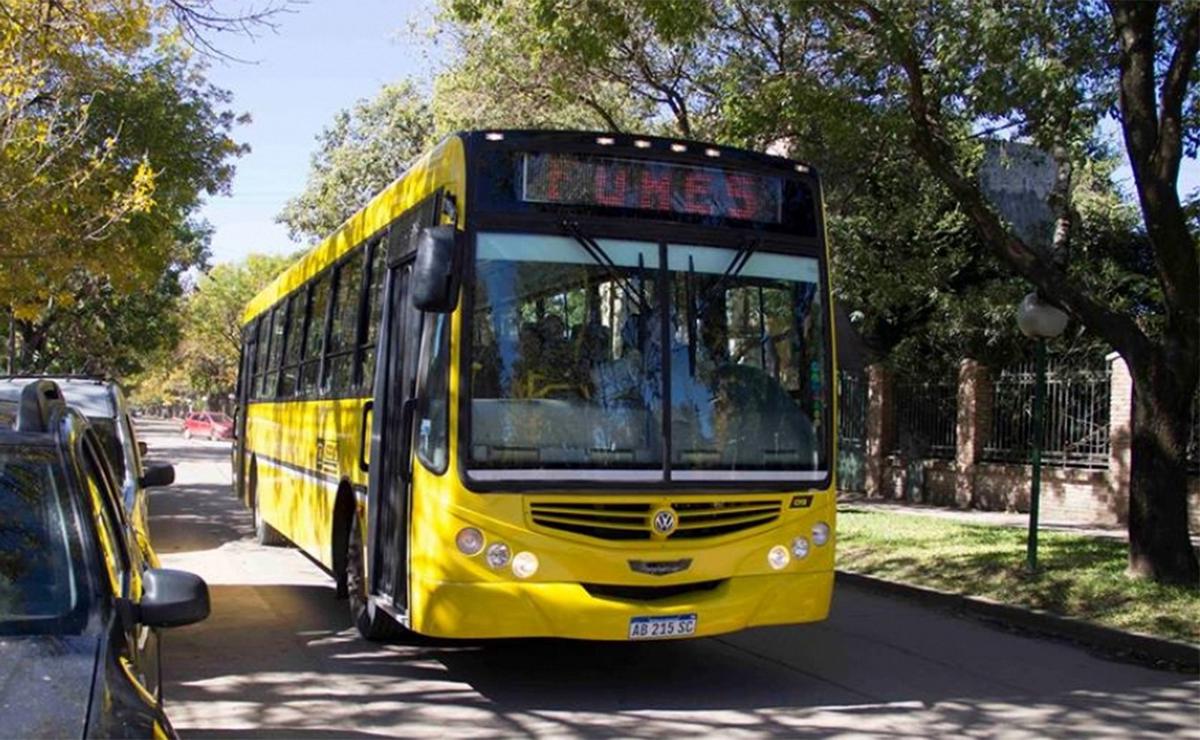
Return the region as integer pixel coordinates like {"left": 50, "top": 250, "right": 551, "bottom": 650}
{"left": 367, "top": 253, "right": 421, "bottom": 613}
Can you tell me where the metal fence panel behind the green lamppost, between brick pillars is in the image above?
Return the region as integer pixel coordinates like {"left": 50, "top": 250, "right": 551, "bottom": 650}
{"left": 983, "top": 363, "right": 1110, "bottom": 468}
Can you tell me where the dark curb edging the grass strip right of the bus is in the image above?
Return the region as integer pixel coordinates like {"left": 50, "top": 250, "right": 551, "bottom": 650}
{"left": 836, "top": 570, "right": 1200, "bottom": 673}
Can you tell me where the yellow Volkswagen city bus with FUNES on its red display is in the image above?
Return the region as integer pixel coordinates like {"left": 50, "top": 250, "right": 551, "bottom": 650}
{"left": 234, "top": 131, "right": 836, "bottom": 640}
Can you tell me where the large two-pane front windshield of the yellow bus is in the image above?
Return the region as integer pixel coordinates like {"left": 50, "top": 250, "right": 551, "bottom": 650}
{"left": 467, "top": 233, "right": 827, "bottom": 481}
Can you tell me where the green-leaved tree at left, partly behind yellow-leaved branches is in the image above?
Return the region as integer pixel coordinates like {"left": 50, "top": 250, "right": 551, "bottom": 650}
{"left": 0, "top": 38, "right": 244, "bottom": 373}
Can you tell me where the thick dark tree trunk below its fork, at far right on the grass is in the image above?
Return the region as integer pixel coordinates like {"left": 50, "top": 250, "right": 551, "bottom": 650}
{"left": 1129, "top": 355, "right": 1200, "bottom": 588}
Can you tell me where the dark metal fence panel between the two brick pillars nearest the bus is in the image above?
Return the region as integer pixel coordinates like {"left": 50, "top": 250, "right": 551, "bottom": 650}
{"left": 890, "top": 381, "right": 959, "bottom": 459}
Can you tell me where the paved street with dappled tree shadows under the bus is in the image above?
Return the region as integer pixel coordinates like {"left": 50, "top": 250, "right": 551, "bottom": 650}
{"left": 136, "top": 421, "right": 1200, "bottom": 738}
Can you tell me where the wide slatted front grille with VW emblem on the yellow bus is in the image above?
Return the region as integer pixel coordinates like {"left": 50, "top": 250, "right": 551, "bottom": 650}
{"left": 529, "top": 499, "right": 782, "bottom": 540}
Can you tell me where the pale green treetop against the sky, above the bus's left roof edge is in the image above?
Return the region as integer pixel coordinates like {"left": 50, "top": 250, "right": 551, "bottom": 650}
{"left": 276, "top": 82, "right": 434, "bottom": 241}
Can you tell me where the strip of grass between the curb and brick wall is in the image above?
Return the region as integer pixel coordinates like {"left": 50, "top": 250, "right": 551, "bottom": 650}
{"left": 838, "top": 506, "right": 1200, "bottom": 643}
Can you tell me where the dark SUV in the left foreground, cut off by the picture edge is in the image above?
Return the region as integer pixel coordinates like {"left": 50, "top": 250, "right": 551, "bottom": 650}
{"left": 0, "top": 380, "right": 209, "bottom": 738}
